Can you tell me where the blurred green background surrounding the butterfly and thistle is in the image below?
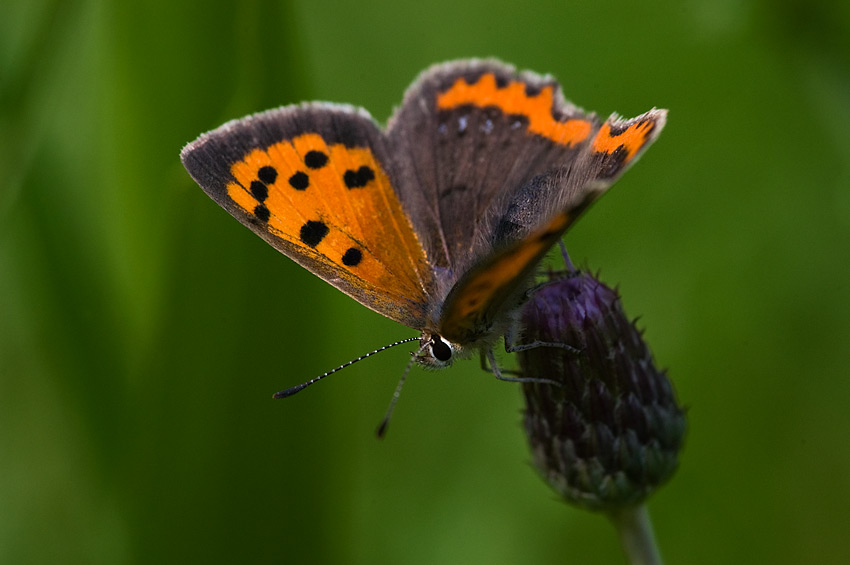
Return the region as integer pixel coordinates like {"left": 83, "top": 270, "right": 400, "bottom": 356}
{"left": 0, "top": 0, "right": 850, "bottom": 564}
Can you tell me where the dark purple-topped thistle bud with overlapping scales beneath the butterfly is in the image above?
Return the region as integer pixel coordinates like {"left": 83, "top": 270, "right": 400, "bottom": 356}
{"left": 518, "top": 266, "right": 686, "bottom": 511}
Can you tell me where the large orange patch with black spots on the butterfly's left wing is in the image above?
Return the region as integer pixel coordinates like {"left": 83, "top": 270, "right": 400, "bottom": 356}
{"left": 227, "top": 133, "right": 430, "bottom": 303}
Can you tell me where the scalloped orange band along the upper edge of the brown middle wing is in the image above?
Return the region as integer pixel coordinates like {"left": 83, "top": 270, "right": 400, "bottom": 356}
{"left": 437, "top": 73, "right": 593, "bottom": 146}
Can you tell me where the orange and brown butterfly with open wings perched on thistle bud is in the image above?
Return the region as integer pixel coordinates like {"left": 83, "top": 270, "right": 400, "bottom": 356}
{"left": 181, "top": 60, "right": 666, "bottom": 384}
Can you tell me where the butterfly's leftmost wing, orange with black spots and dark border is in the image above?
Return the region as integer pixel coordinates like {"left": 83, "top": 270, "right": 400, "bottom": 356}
{"left": 182, "top": 104, "right": 432, "bottom": 328}
